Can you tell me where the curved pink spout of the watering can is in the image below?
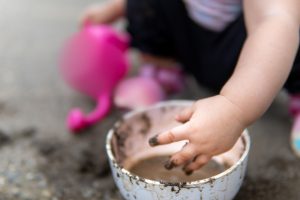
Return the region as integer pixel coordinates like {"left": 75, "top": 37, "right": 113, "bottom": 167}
{"left": 67, "top": 94, "right": 112, "bottom": 133}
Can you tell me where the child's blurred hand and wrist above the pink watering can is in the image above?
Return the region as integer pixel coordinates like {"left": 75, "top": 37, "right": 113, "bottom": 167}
{"left": 80, "top": 0, "right": 125, "bottom": 26}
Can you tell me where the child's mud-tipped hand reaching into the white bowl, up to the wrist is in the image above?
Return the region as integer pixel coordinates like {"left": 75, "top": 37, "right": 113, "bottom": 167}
{"left": 149, "top": 95, "right": 245, "bottom": 174}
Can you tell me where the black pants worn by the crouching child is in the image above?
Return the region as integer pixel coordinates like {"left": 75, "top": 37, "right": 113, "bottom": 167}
{"left": 127, "top": 0, "right": 300, "bottom": 93}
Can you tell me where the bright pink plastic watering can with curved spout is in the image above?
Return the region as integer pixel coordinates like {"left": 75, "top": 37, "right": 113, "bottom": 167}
{"left": 60, "top": 24, "right": 129, "bottom": 132}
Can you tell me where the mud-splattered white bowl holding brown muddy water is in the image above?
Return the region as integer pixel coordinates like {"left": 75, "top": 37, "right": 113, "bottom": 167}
{"left": 106, "top": 101, "right": 250, "bottom": 200}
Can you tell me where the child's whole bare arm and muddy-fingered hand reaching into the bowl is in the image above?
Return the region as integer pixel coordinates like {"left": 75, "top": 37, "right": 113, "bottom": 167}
{"left": 149, "top": 0, "right": 300, "bottom": 173}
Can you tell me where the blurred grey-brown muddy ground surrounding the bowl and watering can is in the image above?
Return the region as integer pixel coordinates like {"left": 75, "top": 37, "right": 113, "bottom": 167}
{"left": 0, "top": 0, "right": 300, "bottom": 200}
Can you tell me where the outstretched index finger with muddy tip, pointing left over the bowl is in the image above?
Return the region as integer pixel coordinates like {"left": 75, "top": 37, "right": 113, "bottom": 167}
{"left": 149, "top": 124, "right": 189, "bottom": 146}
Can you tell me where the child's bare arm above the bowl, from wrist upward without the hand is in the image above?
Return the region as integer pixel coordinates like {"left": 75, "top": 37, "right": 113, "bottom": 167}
{"left": 221, "top": 0, "right": 300, "bottom": 124}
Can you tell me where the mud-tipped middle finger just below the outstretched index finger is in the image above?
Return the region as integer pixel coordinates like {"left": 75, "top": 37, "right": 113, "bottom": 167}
{"left": 165, "top": 144, "right": 197, "bottom": 170}
